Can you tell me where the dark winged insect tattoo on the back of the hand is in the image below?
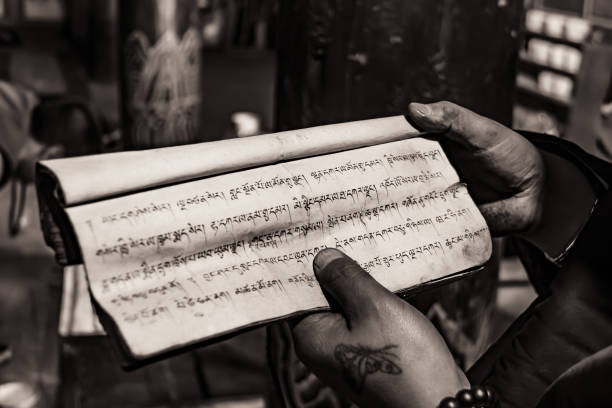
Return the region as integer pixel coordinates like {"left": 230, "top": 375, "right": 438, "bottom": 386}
{"left": 334, "top": 343, "right": 402, "bottom": 392}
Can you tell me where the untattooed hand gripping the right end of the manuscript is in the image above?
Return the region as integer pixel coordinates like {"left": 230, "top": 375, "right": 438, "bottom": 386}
{"left": 409, "top": 102, "right": 545, "bottom": 235}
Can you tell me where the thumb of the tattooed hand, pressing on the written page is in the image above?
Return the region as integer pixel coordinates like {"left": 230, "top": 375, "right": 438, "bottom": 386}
{"left": 314, "top": 248, "right": 392, "bottom": 324}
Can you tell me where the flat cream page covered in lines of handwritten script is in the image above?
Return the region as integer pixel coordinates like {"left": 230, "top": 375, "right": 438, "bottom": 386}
{"left": 67, "top": 138, "right": 491, "bottom": 358}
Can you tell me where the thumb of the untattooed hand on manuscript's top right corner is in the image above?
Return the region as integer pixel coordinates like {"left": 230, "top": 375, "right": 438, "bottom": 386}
{"left": 408, "top": 101, "right": 514, "bottom": 149}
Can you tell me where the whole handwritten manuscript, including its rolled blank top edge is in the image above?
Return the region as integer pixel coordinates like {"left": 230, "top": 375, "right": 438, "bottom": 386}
{"left": 38, "top": 116, "right": 491, "bottom": 360}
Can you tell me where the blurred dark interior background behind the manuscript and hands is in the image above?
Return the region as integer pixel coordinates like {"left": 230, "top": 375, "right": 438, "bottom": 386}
{"left": 0, "top": 0, "right": 612, "bottom": 407}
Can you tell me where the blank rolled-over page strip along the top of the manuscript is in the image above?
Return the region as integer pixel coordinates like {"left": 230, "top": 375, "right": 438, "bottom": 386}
{"left": 37, "top": 115, "right": 421, "bottom": 206}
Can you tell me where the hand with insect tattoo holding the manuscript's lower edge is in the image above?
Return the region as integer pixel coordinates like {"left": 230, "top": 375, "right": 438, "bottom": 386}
{"left": 293, "top": 249, "right": 469, "bottom": 408}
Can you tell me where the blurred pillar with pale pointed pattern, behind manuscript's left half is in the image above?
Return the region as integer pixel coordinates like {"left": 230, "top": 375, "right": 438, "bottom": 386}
{"left": 119, "top": 0, "right": 201, "bottom": 148}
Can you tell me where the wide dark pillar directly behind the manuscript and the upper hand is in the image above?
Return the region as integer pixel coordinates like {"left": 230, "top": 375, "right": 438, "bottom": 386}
{"left": 270, "top": 0, "right": 523, "bottom": 406}
